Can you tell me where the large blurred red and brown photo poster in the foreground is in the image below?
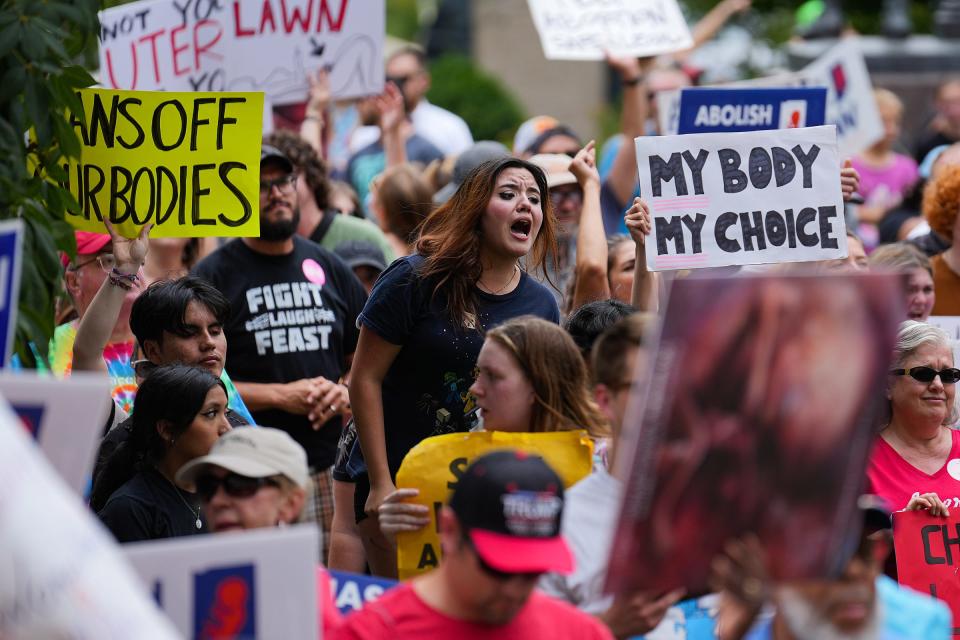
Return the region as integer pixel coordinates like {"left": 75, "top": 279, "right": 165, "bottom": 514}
{"left": 607, "top": 275, "right": 903, "bottom": 593}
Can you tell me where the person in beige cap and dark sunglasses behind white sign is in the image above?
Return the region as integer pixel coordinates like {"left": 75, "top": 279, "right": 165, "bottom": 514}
{"left": 177, "top": 427, "right": 340, "bottom": 636}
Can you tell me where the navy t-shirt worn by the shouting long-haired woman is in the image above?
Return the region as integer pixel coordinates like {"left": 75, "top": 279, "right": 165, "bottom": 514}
{"left": 357, "top": 255, "right": 560, "bottom": 475}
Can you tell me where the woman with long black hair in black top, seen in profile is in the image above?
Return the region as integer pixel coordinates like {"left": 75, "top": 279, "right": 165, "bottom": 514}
{"left": 90, "top": 365, "right": 230, "bottom": 542}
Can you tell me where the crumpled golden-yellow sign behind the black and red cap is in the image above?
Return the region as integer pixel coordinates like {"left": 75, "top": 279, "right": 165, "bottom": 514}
{"left": 397, "top": 431, "right": 593, "bottom": 580}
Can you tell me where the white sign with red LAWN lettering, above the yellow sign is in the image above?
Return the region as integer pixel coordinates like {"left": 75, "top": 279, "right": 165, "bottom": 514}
{"left": 100, "top": 0, "right": 386, "bottom": 105}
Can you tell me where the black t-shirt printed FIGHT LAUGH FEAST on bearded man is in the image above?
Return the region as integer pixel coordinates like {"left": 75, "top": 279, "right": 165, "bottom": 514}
{"left": 194, "top": 236, "right": 367, "bottom": 469}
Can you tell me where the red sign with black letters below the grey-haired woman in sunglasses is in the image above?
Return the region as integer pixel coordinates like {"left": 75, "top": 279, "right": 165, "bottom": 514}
{"left": 893, "top": 511, "right": 960, "bottom": 636}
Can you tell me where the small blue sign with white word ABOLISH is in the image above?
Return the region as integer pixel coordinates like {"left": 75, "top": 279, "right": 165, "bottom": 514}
{"left": 677, "top": 87, "right": 827, "bottom": 133}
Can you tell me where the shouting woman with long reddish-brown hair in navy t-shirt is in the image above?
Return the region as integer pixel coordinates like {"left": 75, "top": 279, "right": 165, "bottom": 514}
{"left": 350, "top": 158, "right": 560, "bottom": 575}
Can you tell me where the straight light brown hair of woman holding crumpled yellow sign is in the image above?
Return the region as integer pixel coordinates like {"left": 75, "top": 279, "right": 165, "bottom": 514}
{"left": 487, "top": 316, "right": 610, "bottom": 438}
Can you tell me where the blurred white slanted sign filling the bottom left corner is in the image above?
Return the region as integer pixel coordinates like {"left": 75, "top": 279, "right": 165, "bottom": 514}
{"left": 0, "top": 398, "right": 180, "bottom": 640}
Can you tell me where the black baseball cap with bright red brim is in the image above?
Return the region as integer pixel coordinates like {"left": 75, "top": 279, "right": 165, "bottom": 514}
{"left": 450, "top": 449, "right": 573, "bottom": 573}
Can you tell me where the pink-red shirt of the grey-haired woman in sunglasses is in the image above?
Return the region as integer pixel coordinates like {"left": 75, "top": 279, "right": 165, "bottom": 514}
{"left": 867, "top": 430, "right": 960, "bottom": 511}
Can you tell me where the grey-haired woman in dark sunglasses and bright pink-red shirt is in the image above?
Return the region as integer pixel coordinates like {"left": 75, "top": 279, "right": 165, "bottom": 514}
{"left": 867, "top": 320, "right": 960, "bottom": 515}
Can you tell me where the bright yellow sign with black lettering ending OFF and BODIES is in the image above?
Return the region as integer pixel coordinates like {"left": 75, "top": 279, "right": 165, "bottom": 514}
{"left": 62, "top": 89, "right": 263, "bottom": 237}
